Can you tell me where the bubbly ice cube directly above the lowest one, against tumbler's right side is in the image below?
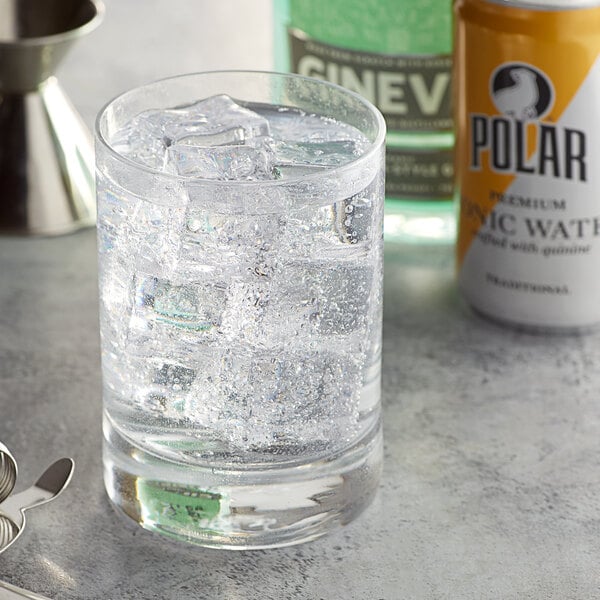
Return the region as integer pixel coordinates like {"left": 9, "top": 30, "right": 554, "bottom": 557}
{"left": 220, "top": 260, "right": 373, "bottom": 356}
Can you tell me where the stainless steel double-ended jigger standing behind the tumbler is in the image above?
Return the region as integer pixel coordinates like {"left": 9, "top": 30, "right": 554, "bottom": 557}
{"left": 0, "top": 0, "right": 104, "bottom": 235}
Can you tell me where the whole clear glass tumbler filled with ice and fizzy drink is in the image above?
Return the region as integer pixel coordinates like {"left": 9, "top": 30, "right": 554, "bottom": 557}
{"left": 96, "top": 71, "right": 385, "bottom": 549}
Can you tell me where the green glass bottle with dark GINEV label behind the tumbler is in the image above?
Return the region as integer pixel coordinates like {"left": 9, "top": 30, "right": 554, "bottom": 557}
{"left": 274, "top": 0, "right": 455, "bottom": 242}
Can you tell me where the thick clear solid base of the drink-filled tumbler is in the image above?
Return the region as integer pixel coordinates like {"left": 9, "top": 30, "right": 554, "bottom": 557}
{"left": 104, "top": 419, "right": 383, "bottom": 550}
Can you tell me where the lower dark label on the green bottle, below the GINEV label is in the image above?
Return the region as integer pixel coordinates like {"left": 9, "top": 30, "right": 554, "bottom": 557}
{"left": 385, "top": 146, "right": 453, "bottom": 200}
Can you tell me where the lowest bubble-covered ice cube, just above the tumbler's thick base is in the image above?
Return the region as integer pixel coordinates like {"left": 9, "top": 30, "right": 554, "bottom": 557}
{"left": 202, "top": 347, "right": 361, "bottom": 452}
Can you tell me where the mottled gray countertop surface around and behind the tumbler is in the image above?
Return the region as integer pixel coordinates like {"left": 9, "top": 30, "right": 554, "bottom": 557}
{"left": 0, "top": 0, "right": 600, "bottom": 600}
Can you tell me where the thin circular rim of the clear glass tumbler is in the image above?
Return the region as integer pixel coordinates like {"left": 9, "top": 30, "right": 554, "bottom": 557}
{"left": 94, "top": 69, "right": 386, "bottom": 187}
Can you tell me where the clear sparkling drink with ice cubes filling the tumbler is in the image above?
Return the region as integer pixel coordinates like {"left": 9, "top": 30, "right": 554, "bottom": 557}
{"left": 98, "top": 88, "right": 383, "bottom": 548}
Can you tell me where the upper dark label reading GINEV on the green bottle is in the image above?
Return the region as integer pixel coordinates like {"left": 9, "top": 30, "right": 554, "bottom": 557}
{"left": 288, "top": 28, "right": 452, "bottom": 131}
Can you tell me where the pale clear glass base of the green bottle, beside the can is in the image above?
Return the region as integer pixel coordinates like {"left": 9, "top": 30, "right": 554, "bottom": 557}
{"left": 384, "top": 198, "right": 456, "bottom": 244}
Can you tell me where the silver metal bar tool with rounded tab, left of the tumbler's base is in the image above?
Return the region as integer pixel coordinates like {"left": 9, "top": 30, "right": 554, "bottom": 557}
{"left": 0, "top": 458, "right": 74, "bottom": 556}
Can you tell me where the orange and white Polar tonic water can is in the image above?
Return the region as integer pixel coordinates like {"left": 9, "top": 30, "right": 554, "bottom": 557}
{"left": 454, "top": 0, "right": 600, "bottom": 330}
